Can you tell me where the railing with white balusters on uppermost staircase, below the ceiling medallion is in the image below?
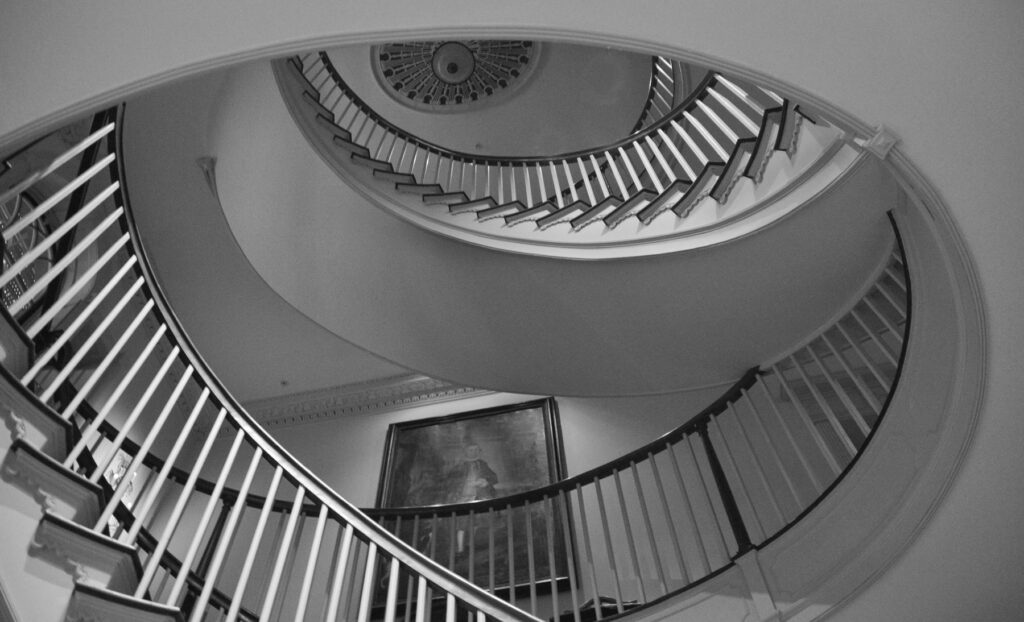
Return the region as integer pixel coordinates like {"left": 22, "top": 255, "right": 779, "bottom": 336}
{"left": 279, "top": 52, "right": 799, "bottom": 232}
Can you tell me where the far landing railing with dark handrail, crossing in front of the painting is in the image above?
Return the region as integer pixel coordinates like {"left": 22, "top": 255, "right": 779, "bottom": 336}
{"left": 70, "top": 216, "right": 909, "bottom": 619}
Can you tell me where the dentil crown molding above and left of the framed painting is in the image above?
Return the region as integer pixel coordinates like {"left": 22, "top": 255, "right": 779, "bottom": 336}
{"left": 243, "top": 375, "right": 494, "bottom": 428}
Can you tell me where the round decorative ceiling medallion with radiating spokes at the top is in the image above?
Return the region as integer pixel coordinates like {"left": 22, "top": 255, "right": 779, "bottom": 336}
{"left": 372, "top": 41, "right": 540, "bottom": 112}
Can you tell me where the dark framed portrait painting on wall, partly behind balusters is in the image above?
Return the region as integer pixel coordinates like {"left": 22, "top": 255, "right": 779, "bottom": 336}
{"left": 377, "top": 398, "right": 574, "bottom": 591}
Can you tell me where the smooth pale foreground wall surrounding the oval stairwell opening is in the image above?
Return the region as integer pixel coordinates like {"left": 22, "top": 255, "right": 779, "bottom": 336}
{"left": 0, "top": 0, "right": 1024, "bottom": 620}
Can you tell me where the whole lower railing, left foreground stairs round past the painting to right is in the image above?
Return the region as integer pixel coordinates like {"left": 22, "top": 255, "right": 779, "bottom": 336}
{"left": 0, "top": 104, "right": 910, "bottom": 621}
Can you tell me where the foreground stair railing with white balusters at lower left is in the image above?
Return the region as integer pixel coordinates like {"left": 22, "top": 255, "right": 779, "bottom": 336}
{"left": 0, "top": 110, "right": 532, "bottom": 621}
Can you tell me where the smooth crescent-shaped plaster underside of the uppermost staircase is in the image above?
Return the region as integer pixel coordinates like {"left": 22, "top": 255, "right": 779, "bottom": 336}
{"left": 203, "top": 64, "right": 895, "bottom": 396}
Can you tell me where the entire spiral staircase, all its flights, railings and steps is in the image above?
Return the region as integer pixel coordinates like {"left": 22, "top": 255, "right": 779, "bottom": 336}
{"left": 0, "top": 3, "right": 1015, "bottom": 621}
